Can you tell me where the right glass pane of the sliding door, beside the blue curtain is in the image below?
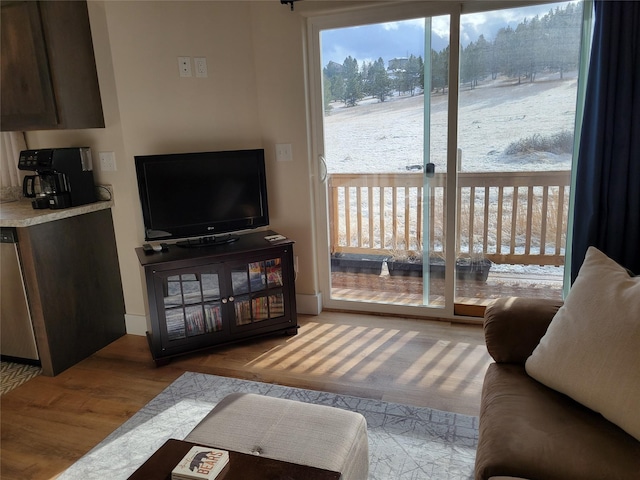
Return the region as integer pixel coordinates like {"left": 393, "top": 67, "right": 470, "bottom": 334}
{"left": 456, "top": 2, "right": 582, "bottom": 298}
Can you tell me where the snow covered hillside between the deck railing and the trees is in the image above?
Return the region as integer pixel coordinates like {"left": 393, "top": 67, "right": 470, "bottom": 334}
{"left": 324, "top": 75, "right": 577, "bottom": 173}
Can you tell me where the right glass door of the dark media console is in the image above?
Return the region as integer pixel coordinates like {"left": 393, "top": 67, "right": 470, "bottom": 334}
{"left": 231, "top": 257, "right": 285, "bottom": 326}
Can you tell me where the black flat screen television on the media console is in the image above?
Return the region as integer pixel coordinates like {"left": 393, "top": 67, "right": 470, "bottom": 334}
{"left": 135, "top": 149, "right": 269, "bottom": 246}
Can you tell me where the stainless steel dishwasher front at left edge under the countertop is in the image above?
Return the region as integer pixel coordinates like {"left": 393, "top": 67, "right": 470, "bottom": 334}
{"left": 0, "top": 227, "right": 39, "bottom": 360}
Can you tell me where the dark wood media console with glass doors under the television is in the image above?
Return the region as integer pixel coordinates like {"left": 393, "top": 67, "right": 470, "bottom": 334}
{"left": 136, "top": 230, "right": 298, "bottom": 365}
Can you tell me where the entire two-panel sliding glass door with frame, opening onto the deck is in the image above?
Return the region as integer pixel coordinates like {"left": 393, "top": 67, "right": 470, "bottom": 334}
{"left": 308, "top": 2, "right": 582, "bottom": 316}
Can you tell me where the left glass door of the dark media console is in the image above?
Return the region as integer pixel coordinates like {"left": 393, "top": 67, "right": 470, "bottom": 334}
{"left": 162, "top": 271, "right": 223, "bottom": 341}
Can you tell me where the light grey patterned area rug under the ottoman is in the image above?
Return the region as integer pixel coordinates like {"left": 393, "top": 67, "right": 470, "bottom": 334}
{"left": 58, "top": 372, "right": 478, "bottom": 480}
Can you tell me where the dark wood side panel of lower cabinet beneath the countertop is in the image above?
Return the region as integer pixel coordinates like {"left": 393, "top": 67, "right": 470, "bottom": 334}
{"left": 16, "top": 207, "right": 126, "bottom": 376}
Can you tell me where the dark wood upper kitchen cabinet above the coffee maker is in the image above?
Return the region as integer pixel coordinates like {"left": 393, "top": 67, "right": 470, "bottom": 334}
{"left": 0, "top": 1, "right": 104, "bottom": 131}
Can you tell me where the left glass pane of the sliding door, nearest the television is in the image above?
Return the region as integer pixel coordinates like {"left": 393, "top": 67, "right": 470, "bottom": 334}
{"left": 320, "top": 17, "right": 449, "bottom": 307}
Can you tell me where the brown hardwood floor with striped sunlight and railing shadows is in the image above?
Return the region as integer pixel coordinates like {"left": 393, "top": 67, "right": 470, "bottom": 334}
{"left": 0, "top": 312, "right": 491, "bottom": 480}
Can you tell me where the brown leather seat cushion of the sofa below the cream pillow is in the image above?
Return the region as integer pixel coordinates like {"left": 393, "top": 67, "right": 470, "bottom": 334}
{"left": 475, "top": 363, "right": 640, "bottom": 480}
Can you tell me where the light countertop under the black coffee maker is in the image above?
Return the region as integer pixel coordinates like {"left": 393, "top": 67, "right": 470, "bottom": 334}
{"left": 0, "top": 198, "right": 113, "bottom": 227}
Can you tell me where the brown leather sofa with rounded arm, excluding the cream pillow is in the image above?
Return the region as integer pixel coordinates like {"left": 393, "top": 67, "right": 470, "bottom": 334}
{"left": 475, "top": 298, "right": 640, "bottom": 480}
